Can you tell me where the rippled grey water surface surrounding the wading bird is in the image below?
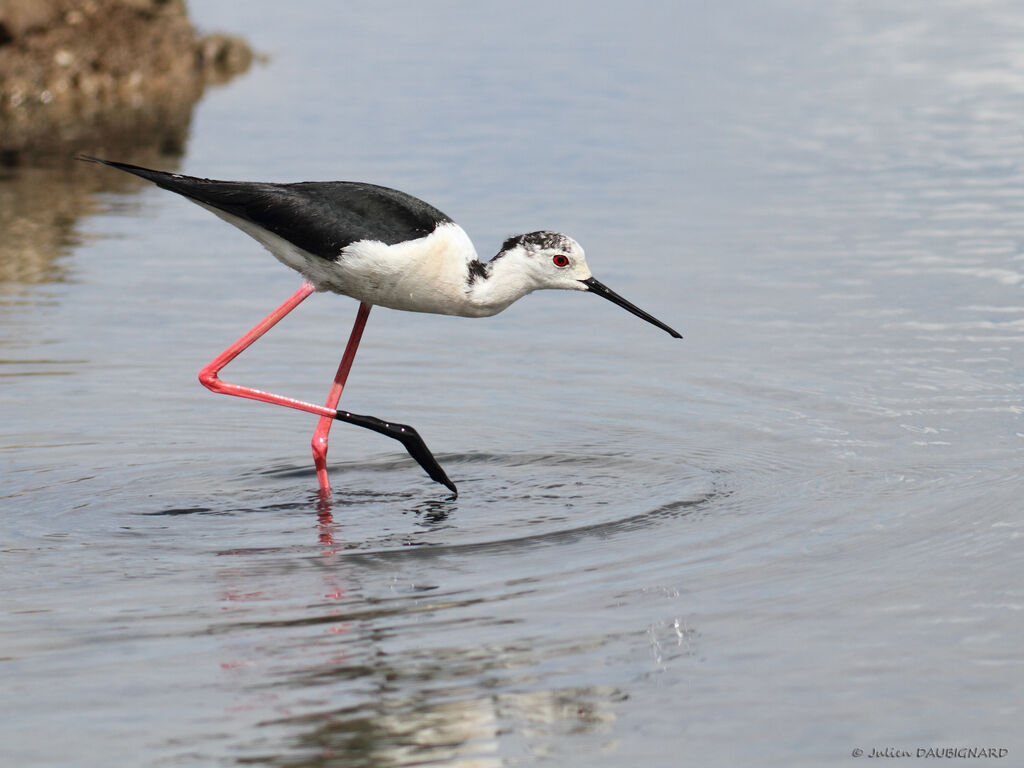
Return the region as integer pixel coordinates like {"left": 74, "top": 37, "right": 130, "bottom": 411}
{"left": 0, "top": 0, "right": 1024, "bottom": 767}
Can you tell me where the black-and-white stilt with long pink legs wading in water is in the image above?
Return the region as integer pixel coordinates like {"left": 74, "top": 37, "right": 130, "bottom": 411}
{"left": 80, "top": 155, "right": 681, "bottom": 497}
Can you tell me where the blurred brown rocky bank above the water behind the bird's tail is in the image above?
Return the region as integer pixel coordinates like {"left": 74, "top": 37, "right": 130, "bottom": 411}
{"left": 0, "top": 0, "right": 253, "bottom": 162}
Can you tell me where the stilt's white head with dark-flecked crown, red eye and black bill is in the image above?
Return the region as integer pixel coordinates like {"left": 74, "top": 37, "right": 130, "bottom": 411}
{"left": 496, "top": 229, "right": 682, "bottom": 339}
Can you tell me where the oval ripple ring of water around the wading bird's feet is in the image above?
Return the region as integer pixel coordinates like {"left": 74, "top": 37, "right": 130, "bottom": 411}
{"left": 147, "top": 453, "right": 724, "bottom": 552}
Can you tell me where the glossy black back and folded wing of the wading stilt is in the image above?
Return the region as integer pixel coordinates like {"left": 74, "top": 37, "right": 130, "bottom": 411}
{"left": 81, "top": 155, "right": 452, "bottom": 260}
